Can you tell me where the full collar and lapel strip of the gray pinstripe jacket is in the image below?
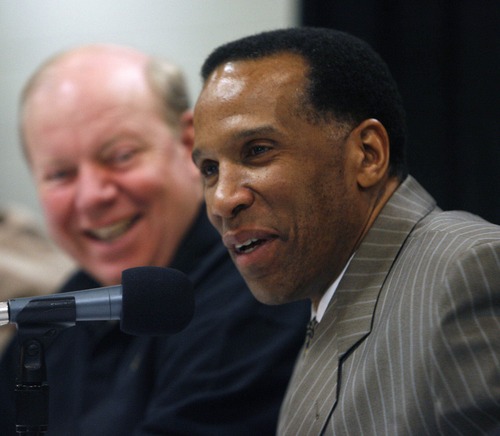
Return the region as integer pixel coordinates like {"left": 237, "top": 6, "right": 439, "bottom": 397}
{"left": 279, "top": 177, "right": 435, "bottom": 434}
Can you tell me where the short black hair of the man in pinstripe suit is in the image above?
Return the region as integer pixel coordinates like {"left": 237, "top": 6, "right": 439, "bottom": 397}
{"left": 201, "top": 27, "right": 408, "bottom": 180}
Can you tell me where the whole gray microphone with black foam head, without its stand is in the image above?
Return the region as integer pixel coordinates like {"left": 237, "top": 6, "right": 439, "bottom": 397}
{"left": 0, "top": 266, "right": 194, "bottom": 336}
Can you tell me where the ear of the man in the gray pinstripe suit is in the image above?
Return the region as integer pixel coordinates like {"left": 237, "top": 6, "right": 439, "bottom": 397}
{"left": 351, "top": 118, "right": 390, "bottom": 188}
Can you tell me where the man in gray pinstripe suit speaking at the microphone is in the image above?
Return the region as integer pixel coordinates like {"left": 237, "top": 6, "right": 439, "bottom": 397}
{"left": 193, "top": 28, "right": 500, "bottom": 435}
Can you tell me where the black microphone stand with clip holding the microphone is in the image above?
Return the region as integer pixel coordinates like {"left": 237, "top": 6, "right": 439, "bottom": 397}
{"left": 15, "top": 296, "right": 76, "bottom": 436}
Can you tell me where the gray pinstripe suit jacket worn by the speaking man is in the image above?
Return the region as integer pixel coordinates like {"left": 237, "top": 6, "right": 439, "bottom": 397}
{"left": 278, "top": 177, "right": 500, "bottom": 436}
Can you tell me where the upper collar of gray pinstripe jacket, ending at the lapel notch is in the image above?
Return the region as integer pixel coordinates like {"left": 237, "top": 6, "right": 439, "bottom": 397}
{"left": 332, "top": 177, "right": 435, "bottom": 359}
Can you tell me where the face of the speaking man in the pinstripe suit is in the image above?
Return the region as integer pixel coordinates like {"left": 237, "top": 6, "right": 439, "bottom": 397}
{"left": 193, "top": 54, "right": 382, "bottom": 304}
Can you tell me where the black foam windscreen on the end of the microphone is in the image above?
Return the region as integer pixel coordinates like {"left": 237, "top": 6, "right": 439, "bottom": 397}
{"left": 120, "top": 266, "right": 194, "bottom": 336}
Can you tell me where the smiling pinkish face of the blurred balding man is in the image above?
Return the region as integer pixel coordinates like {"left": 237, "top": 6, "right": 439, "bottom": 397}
{"left": 23, "top": 48, "right": 202, "bottom": 285}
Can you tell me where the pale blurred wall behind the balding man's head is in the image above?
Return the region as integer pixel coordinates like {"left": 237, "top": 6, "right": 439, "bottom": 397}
{"left": 0, "top": 0, "right": 298, "bottom": 221}
